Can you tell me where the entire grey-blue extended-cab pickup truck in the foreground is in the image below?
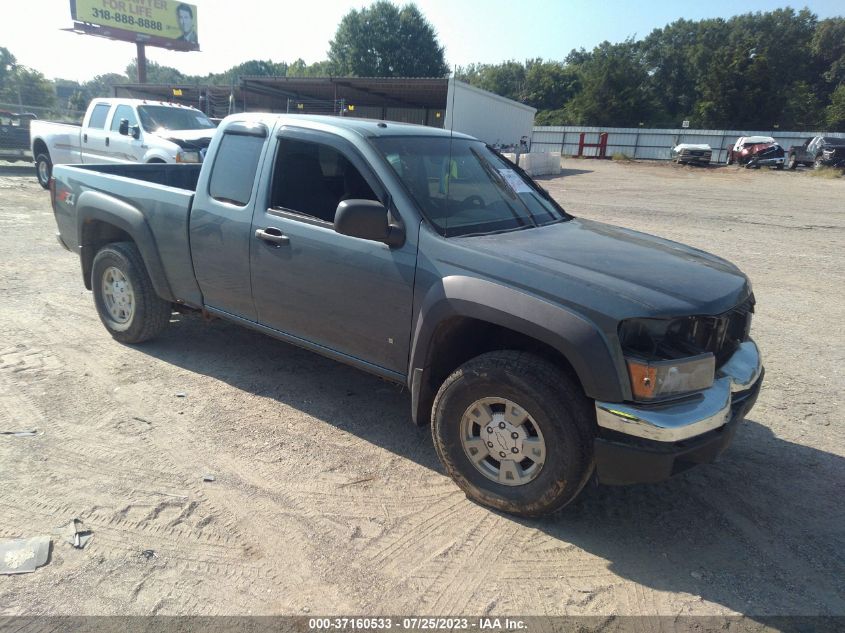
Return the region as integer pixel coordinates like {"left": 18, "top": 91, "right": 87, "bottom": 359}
{"left": 51, "top": 114, "right": 763, "bottom": 516}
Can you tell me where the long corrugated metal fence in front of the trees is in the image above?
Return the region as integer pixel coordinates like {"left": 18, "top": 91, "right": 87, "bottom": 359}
{"left": 531, "top": 125, "right": 845, "bottom": 162}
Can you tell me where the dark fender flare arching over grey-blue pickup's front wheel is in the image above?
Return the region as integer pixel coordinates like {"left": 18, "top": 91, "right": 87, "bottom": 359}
{"left": 408, "top": 276, "right": 630, "bottom": 424}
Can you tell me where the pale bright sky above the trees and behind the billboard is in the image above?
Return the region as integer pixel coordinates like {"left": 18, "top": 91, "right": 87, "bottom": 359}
{"left": 0, "top": 0, "right": 845, "bottom": 81}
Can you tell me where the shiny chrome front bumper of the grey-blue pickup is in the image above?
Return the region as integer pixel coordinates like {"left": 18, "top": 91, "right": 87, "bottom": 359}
{"left": 596, "top": 341, "right": 763, "bottom": 442}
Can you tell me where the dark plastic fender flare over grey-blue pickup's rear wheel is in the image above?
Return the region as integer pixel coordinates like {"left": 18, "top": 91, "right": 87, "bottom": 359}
{"left": 77, "top": 191, "right": 175, "bottom": 301}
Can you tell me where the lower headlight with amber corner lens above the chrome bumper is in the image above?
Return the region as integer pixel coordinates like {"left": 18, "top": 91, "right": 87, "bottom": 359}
{"left": 625, "top": 353, "right": 716, "bottom": 401}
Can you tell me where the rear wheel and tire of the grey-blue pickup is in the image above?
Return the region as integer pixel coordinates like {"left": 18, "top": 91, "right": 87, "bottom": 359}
{"left": 91, "top": 242, "right": 172, "bottom": 344}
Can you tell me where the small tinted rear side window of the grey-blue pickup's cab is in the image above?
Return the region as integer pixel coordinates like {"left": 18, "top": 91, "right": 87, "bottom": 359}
{"left": 208, "top": 134, "right": 265, "bottom": 207}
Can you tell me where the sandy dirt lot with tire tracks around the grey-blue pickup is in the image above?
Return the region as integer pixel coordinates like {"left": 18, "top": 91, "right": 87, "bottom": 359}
{"left": 0, "top": 160, "right": 845, "bottom": 630}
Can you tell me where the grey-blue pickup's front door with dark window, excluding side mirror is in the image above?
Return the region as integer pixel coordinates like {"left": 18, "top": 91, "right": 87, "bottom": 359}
{"left": 251, "top": 127, "right": 418, "bottom": 377}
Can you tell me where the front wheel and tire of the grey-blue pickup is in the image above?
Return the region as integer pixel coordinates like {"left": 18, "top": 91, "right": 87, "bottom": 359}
{"left": 432, "top": 351, "right": 595, "bottom": 517}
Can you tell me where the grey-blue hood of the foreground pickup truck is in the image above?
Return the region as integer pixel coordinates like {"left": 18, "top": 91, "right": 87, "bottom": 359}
{"left": 455, "top": 219, "right": 751, "bottom": 318}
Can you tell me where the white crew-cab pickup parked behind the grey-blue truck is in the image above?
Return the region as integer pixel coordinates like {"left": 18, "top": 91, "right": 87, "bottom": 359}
{"left": 29, "top": 98, "right": 215, "bottom": 189}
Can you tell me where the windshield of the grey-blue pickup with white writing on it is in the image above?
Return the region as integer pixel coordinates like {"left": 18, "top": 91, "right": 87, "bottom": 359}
{"left": 373, "top": 136, "right": 569, "bottom": 237}
